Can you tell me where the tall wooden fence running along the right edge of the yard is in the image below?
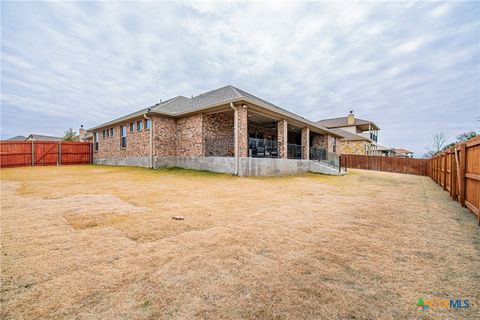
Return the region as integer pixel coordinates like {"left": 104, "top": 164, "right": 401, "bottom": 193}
{"left": 427, "top": 136, "right": 480, "bottom": 225}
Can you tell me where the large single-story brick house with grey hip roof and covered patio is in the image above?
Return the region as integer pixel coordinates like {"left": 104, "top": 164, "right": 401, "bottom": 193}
{"left": 88, "top": 86, "right": 341, "bottom": 175}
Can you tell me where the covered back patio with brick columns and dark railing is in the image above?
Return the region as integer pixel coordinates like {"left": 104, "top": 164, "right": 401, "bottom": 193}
{"left": 204, "top": 104, "right": 336, "bottom": 161}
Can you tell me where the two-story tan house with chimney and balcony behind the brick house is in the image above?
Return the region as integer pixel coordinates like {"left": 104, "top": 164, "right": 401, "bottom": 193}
{"left": 317, "top": 111, "right": 383, "bottom": 155}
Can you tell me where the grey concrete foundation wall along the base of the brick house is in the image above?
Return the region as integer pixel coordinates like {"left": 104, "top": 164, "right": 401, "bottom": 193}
{"left": 94, "top": 157, "right": 338, "bottom": 177}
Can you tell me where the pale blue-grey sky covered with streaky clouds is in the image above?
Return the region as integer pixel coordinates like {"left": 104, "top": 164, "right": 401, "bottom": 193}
{"left": 1, "top": 1, "right": 480, "bottom": 156}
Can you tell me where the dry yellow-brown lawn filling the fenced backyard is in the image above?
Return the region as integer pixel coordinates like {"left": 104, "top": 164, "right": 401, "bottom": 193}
{"left": 0, "top": 166, "right": 480, "bottom": 320}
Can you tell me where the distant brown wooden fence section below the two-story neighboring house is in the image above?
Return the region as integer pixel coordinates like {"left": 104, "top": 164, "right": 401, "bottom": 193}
{"left": 341, "top": 154, "right": 428, "bottom": 176}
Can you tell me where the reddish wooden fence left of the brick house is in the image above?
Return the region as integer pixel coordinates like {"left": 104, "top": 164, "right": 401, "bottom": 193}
{"left": 0, "top": 141, "right": 93, "bottom": 168}
